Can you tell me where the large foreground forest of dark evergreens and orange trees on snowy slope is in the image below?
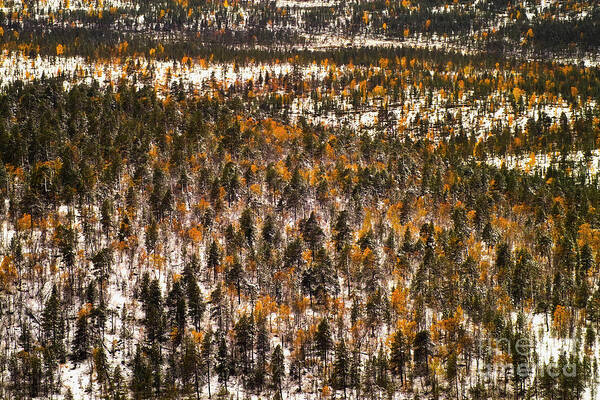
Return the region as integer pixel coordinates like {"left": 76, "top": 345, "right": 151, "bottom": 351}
{"left": 0, "top": 72, "right": 600, "bottom": 399}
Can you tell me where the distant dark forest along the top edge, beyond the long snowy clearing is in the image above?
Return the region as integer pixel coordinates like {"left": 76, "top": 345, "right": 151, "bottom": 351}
{"left": 0, "top": 0, "right": 600, "bottom": 59}
